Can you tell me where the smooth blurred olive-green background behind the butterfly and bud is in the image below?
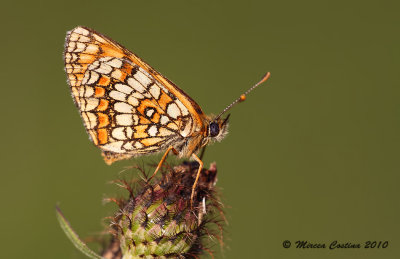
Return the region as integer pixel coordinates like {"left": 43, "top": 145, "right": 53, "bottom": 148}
{"left": 0, "top": 0, "right": 400, "bottom": 259}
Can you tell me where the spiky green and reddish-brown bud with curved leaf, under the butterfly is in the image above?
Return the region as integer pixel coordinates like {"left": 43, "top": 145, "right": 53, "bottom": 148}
{"left": 59, "top": 162, "right": 224, "bottom": 259}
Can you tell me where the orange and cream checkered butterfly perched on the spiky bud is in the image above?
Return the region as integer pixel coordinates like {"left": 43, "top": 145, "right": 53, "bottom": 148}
{"left": 64, "top": 27, "right": 270, "bottom": 205}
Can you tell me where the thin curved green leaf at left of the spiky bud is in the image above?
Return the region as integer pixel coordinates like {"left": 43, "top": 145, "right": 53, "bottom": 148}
{"left": 56, "top": 206, "right": 105, "bottom": 259}
